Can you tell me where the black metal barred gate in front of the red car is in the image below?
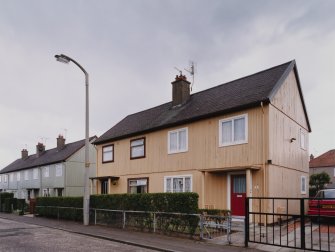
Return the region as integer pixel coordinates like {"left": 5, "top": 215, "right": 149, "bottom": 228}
{"left": 245, "top": 197, "right": 335, "bottom": 251}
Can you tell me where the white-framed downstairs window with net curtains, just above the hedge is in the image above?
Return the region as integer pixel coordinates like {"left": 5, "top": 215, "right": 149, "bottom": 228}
{"left": 164, "top": 175, "right": 192, "bottom": 193}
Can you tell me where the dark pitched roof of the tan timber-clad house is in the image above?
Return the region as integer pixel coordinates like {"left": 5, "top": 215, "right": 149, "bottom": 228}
{"left": 94, "top": 60, "right": 310, "bottom": 144}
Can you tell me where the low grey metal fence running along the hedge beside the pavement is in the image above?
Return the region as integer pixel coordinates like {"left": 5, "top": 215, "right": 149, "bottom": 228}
{"left": 36, "top": 206, "right": 231, "bottom": 243}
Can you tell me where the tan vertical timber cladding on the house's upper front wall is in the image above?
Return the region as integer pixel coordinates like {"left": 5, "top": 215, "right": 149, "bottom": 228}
{"left": 97, "top": 107, "right": 263, "bottom": 176}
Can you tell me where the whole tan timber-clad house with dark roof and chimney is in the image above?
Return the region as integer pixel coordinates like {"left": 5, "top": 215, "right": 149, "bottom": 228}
{"left": 91, "top": 61, "right": 311, "bottom": 215}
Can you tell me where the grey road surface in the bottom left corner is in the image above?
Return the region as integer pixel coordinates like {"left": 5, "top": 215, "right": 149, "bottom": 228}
{"left": 0, "top": 219, "right": 153, "bottom": 252}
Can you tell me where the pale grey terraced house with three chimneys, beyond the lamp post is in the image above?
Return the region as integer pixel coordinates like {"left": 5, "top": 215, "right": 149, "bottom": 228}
{"left": 0, "top": 135, "right": 96, "bottom": 200}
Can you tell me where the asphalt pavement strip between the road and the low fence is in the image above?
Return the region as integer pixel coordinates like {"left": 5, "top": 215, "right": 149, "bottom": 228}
{"left": 0, "top": 213, "right": 260, "bottom": 252}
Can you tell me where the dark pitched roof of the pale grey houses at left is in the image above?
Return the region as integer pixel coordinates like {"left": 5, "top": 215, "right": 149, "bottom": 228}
{"left": 0, "top": 136, "right": 96, "bottom": 174}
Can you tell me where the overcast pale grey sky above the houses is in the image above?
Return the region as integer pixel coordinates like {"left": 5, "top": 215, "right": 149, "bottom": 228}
{"left": 0, "top": 0, "right": 335, "bottom": 169}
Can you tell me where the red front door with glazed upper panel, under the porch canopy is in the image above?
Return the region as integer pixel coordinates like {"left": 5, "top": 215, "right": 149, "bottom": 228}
{"left": 231, "top": 175, "right": 246, "bottom": 216}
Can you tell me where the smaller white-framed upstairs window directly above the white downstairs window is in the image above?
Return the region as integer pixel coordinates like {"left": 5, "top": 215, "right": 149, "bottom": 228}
{"left": 168, "top": 128, "right": 188, "bottom": 154}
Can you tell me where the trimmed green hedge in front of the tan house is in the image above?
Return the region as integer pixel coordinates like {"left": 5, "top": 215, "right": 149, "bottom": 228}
{"left": 36, "top": 193, "right": 199, "bottom": 235}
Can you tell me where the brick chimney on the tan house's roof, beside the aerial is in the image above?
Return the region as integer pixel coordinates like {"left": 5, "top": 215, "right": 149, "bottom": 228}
{"left": 171, "top": 74, "right": 191, "bottom": 107}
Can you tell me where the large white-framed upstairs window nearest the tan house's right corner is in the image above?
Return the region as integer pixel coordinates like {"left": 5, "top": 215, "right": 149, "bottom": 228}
{"left": 219, "top": 115, "right": 248, "bottom": 147}
